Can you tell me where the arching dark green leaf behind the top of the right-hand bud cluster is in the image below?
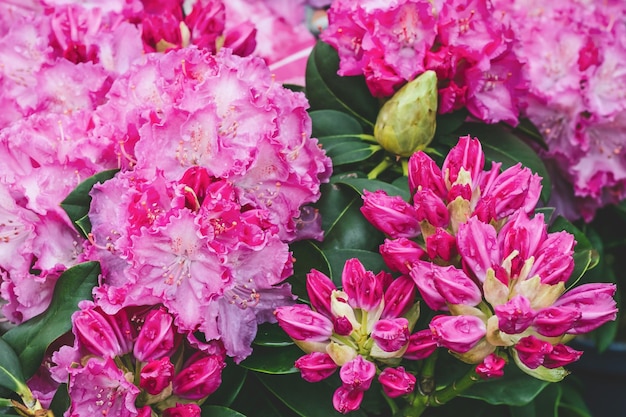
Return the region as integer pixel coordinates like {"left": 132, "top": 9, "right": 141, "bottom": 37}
{"left": 462, "top": 123, "right": 552, "bottom": 202}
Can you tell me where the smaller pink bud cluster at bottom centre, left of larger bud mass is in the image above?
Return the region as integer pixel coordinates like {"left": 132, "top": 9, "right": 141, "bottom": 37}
{"left": 275, "top": 258, "right": 436, "bottom": 413}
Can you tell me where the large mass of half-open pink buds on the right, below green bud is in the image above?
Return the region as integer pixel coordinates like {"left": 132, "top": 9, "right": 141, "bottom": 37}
{"left": 362, "top": 137, "right": 617, "bottom": 380}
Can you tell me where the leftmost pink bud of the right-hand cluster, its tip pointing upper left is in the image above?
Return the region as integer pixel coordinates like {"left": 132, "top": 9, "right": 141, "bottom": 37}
{"left": 361, "top": 190, "right": 420, "bottom": 238}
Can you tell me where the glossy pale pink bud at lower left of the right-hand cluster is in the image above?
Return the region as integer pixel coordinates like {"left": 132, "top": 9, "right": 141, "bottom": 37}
{"left": 429, "top": 316, "right": 487, "bottom": 353}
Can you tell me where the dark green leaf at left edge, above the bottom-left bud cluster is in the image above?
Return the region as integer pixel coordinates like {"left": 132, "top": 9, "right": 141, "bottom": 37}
{"left": 3, "top": 262, "right": 100, "bottom": 379}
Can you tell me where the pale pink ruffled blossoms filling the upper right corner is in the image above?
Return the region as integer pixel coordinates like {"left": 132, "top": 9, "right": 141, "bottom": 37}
{"left": 494, "top": 1, "right": 626, "bottom": 221}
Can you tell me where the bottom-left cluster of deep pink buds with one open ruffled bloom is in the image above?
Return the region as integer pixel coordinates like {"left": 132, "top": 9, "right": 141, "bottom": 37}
{"left": 51, "top": 301, "right": 225, "bottom": 417}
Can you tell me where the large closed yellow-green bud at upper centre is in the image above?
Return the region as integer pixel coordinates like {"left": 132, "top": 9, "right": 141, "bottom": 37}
{"left": 374, "top": 71, "right": 437, "bottom": 157}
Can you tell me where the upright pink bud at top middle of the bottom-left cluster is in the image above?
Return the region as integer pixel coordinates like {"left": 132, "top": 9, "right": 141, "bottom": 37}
{"left": 133, "top": 307, "right": 176, "bottom": 362}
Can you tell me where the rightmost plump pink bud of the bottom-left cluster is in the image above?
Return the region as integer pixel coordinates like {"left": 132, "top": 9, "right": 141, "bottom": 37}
{"left": 172, "top": 351, "right": 226, "bottom": 400}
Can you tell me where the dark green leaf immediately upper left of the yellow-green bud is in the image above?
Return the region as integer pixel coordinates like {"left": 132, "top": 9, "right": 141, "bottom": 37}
{"left": 306, "top": 41, "right": 380, "bottom": 129}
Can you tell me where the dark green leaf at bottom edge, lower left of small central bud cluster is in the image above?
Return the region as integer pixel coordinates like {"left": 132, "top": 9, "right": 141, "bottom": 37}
{"left": 258, "top": 374, "right": 367, "bottom": 417}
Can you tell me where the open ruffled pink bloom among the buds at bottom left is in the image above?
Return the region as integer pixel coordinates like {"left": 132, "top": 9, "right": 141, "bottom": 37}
{"left": 66, "top": 357, "right": 139, "bottom": 417}
